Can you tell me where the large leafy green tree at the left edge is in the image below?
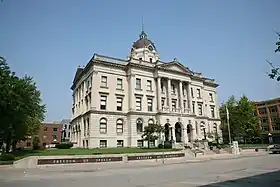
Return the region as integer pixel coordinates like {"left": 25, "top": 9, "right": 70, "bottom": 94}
{"left": 0, "top": 58, "right": 45, "bottom": 151}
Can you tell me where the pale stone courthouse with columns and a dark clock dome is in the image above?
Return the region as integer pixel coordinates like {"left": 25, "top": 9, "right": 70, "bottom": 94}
{"left": 71, "top": 31, "right": 221, "bottom": 148}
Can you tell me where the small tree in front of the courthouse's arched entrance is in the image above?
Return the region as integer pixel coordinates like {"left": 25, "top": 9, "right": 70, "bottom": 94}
{"left": 142, "top": 123, "right": 164, "bottom": 148}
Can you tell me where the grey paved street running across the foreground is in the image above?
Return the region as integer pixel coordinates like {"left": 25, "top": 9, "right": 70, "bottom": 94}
{"left": 0, "top": 154, "right": 280, "bottom": 187}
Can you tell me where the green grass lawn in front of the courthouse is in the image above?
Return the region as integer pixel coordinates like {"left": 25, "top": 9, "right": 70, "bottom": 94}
{"left": 13, "top": 148, "right": 180, "bottom": 160}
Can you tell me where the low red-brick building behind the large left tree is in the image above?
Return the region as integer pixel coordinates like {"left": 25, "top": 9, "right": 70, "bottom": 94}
{"left": 18, "top": 122, "right": 62, "bottom": 148}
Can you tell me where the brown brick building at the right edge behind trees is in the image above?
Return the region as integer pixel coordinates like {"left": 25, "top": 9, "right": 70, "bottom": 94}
{"left": 255, "top": 98, "right": 280, "bottom": 142}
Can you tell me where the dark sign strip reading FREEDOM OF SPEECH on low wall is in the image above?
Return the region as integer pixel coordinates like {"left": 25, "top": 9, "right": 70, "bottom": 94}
{"left": 37, "top": 157, "right": 123, "bottom": 165}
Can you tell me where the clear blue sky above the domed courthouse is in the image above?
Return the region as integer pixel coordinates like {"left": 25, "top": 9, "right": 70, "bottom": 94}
{"left": 0, "top": 0, "right": 280, "bottom": 121}
